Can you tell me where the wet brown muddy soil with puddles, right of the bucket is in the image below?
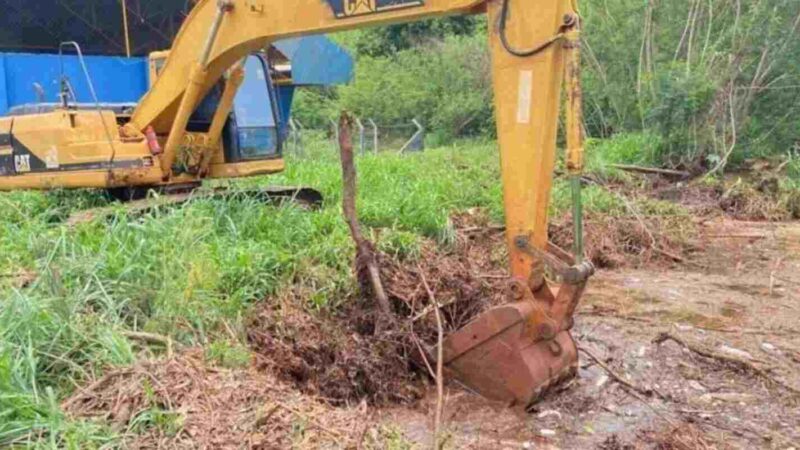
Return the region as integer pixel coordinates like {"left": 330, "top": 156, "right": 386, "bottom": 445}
{"left": 384, "top": 219, "right": 800, "bottom": 449}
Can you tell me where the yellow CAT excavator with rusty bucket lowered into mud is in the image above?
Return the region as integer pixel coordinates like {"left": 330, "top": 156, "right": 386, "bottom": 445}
{"left": 0, "top": 0, "right": 594, "bottom": 406}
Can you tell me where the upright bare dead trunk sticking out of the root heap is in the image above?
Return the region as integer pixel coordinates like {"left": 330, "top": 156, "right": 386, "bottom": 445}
{"left": 339, "top": 112, "right": 392, "bottom": 318}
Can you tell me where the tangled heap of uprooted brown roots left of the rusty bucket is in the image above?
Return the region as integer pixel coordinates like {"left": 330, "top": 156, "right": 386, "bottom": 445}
{"left": 248, "top": 211, "right": 504, "bottom": 405}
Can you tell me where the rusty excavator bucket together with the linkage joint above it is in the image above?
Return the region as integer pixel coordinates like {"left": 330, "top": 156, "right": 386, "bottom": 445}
{"left": 442, "top": 242, "right": 594, "bottom": 408}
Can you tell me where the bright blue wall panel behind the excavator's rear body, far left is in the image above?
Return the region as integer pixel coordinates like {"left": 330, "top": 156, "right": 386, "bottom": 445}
{"left": 0, "top": 53, "right": 148, "bottom": 114}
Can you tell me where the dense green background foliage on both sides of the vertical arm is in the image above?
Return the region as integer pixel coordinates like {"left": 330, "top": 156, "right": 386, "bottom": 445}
{"left": 298, "top": 0, "right": 800, "bottom": 171}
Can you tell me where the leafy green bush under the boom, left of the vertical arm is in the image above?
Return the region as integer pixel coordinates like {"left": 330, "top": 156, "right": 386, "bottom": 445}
{"left": 339, "top": 33, "right": 493, "bottom": 145}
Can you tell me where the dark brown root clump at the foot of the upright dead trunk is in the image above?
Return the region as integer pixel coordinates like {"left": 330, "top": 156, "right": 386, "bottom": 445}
{"left": 248, "top": 294, "right": 423, "bottom": 405}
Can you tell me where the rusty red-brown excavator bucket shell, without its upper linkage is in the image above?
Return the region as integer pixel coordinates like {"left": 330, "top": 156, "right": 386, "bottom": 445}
{"left": 444, "top": 302, "right": 578, "bottom": 407}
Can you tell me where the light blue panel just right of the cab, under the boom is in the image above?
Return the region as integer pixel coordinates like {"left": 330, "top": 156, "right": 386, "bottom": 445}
{"left": 272, "top": 36, "right": 353, "bottom": 86}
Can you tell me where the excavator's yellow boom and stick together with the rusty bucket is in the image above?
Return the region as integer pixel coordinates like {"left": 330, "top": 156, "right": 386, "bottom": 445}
{"left": 133, "top": 0, "right": 592, "bottom": 405}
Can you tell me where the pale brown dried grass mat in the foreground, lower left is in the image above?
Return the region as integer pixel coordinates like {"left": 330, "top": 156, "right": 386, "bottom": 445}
{"left": 64, "top": 349, "right": 371, "bottom": 449}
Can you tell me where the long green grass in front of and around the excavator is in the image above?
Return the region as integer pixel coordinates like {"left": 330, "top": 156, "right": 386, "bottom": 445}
{"left": 0, "top": 138, "right": 688, "bottom": 448}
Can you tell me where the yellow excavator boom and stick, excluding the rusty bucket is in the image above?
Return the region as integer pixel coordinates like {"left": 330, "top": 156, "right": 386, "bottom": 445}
{"left": 134, "top": 0, "right": 577, "bottom": 284}
